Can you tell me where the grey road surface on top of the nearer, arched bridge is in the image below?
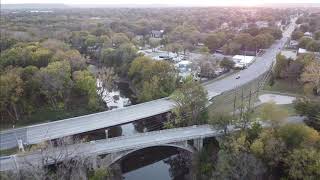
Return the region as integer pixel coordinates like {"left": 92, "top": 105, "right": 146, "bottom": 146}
{"left": 0, "top": 116, "right": 303, "bottom": 171}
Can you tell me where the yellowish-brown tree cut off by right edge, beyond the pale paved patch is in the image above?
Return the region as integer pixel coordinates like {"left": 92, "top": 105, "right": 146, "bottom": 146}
{"left": 301, "top": 61, "right": 320, "bottom": 95}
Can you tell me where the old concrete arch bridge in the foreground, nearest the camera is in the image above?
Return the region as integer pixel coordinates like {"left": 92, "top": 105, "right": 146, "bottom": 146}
{"left": 0, "top": 116, "right": 304, "bottom": 171}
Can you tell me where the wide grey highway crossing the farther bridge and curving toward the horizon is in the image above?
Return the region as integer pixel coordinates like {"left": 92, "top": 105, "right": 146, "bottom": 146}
{"left": 0, "top": 18, "right": 294, "bottom": 150}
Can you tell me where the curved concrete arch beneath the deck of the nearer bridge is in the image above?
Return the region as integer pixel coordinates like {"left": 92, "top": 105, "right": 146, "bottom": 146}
{"left": 107, "top": 142, "right": 195, "bottom": 166}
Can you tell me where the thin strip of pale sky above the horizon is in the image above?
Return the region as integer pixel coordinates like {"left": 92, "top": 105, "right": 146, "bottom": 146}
{"left": 0, "top": 0, "right": 320, "bottom": 6}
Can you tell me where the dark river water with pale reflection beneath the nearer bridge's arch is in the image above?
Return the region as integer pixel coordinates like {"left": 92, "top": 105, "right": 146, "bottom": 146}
{"left": 119, "top": 146, "right": 191, "bottom": 180}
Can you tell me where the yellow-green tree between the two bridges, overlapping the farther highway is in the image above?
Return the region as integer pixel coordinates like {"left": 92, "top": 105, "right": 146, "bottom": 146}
{"left": 171, "top": 77, "right": 208, "bottom": 126}
